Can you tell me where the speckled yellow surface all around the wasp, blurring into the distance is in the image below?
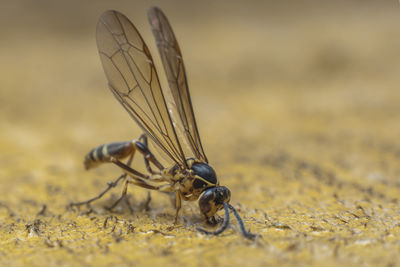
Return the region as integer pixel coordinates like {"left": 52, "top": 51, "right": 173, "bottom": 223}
{"left": 0, "top": 1, "right": 400, "bottom": 266}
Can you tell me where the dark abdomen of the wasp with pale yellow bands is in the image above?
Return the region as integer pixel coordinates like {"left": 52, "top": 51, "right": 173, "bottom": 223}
{"left": 84, "top": 141, "right": 135, "bottom": 169}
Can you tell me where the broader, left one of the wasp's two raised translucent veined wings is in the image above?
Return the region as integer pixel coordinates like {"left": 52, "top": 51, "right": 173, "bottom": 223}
{"left": 96, "top": 10, "right": 186, "bottom": 169}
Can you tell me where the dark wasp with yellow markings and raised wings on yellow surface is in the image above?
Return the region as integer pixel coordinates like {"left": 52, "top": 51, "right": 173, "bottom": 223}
{"left": 71, "top": 7, "right": 255, "bottom": 239}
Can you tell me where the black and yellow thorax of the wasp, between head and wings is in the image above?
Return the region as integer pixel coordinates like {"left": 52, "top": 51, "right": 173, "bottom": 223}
{"left": 174, "top": 159, "right": 218, "bottom": 200}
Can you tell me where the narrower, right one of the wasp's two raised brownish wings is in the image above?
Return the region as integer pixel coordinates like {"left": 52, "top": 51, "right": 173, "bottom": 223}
{"left": 148, "top": 7, "right": 207, "bottom": 162}
